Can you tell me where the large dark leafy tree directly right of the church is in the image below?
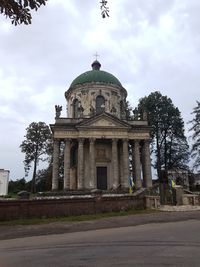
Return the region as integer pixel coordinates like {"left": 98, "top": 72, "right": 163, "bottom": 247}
{"left": 138, "top": 91, "right": 189, "bottom": 180}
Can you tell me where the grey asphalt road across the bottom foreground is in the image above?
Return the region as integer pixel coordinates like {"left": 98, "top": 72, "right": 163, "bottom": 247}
{"left": 0, "top": 219, "right": 200, "bottom": 267}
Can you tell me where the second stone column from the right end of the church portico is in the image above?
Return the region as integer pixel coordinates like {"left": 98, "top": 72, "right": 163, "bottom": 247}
{"left": 132, "top": 140, "right": 142, "bottom": 189}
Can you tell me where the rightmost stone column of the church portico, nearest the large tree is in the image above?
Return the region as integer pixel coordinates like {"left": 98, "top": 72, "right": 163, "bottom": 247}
{"left": 142, "top": 140, "right": 152, "bottom": 188}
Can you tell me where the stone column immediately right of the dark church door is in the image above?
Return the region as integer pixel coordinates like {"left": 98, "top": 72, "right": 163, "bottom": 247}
{"left": 112, "top": 139, "right": 119, "bottom": 189}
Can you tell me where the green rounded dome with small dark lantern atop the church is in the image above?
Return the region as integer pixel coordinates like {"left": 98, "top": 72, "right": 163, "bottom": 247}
{"left": 70, "top": 60, "right": 122, "bottom": 87}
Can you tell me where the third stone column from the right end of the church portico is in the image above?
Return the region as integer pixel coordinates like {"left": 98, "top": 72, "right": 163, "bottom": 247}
{"left": 121, "top": 139, "right": 129, "bottom": 188}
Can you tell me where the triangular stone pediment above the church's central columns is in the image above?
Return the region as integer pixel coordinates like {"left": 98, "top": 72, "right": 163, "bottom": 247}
{"left": 77, "top": 113, "right": 130, "bottom": 128}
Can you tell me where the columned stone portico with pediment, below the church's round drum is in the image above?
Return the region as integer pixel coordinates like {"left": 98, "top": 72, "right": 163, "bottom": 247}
{"left": 52, "top": 113, "right": 152, "bottom": 190}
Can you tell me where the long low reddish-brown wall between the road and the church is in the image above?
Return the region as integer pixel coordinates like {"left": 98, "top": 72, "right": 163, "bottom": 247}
{"left": 0, "top": 195, "right": 155, "bottom": 221}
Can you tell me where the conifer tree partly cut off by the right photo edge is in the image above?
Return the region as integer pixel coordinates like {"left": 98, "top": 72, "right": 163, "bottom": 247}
{"left": 190, "top": 101, "right": 200, "bottom": 171}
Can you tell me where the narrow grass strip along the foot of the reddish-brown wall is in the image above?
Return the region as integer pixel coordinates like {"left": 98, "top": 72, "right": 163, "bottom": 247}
{"left": 0, "top": 210, "right": 159, "bottom": 226}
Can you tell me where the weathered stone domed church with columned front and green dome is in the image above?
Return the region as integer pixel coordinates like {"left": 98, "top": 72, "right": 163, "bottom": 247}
{"left": 50, "top": 60, "right": 152, "bottom": 190}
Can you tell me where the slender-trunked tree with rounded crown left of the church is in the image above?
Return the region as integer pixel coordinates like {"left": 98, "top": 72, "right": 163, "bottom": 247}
{"left": 20, "top": 122, "right": 52, "bottom": 193}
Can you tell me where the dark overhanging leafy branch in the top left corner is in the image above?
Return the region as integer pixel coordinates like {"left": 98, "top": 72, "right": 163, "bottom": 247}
{"left": 0, "top": 0, "right": 47, "bottom": 25}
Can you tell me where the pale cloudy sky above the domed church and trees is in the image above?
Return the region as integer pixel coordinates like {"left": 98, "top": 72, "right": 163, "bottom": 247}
{"left": 0, "top": 0, "right": 200, "bottom": 180}
